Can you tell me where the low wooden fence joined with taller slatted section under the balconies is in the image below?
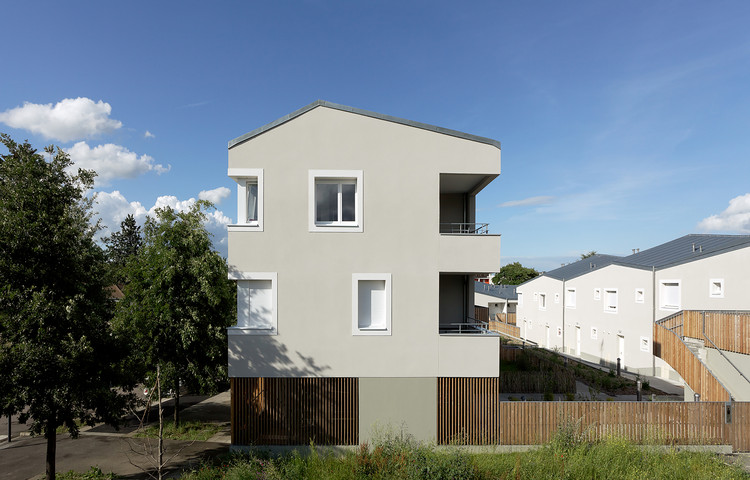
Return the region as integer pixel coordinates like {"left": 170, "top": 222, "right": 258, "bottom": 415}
{"left": 437, "top": 378, "right": 750, "bottom": 451}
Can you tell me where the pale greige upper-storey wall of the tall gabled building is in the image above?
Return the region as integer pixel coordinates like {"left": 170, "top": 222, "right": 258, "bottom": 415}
{"left": 228, "top": 107, "right": 500, "bottom": 377}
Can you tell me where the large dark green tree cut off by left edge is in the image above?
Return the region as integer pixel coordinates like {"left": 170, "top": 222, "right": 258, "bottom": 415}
{"left": 0, "top": 134, "right": 131, "bottom": 479}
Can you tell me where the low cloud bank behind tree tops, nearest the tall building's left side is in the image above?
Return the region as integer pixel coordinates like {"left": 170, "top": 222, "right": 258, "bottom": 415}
{"left": 95, "top": 190, "right": 232, "bottom": 257}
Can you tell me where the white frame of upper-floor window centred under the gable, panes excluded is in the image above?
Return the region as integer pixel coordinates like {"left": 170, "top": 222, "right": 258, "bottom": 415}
{"left": 308, "top": 170, "right": 364, "bottom": 232}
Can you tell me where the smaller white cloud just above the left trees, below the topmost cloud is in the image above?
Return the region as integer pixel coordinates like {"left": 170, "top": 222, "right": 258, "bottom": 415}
{"left": 66, "top": 142, "right": 170, "bottom": 184}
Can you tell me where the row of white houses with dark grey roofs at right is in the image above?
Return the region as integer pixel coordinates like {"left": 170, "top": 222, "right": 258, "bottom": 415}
{"left": 517, "top": 235, "right": 750, "bottom": 394}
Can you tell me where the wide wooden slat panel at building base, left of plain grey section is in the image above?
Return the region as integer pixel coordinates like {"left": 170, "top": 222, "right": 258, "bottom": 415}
{"left": 230, "top": 378, "right": 359, "bottom": 445}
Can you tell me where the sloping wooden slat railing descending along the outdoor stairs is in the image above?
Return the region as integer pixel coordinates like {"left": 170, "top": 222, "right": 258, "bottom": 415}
{"left": 654, "top": 314, "right": 730, "bottom": 402}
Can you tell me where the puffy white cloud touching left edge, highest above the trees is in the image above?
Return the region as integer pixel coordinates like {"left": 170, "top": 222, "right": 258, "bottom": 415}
{"left": 0, "top": 97, "right": 122, "bottom": 142}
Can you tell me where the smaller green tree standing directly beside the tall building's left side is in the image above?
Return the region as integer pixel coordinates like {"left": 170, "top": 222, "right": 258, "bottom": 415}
{"left": 115, "top": 201, "right": 236, "bottom": 425}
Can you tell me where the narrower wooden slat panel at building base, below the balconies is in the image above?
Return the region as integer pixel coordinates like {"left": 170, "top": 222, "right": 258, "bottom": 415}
{"left": 437, "top": 377, "right": 500, "bottom": 445}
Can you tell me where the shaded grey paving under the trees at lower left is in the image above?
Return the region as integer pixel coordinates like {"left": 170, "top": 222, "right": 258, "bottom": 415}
{"left": 0, "top": 392, "right": 230, "bottom": 480}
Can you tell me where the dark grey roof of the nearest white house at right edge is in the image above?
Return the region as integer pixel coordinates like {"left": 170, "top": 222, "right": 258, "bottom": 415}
{"left": 617, "top": 234, "right": 750, "bottom": 270}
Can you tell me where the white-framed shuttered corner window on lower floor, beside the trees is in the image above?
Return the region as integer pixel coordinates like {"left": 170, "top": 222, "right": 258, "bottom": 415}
{"left": 228, "top": 272, "right": 278, "bottom": 335}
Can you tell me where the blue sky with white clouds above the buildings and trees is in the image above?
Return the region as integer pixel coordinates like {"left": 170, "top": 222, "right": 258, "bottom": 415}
{"left": 0, "top": 1, "right": 750, "bottom": 270}
